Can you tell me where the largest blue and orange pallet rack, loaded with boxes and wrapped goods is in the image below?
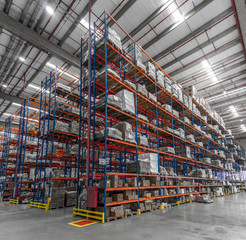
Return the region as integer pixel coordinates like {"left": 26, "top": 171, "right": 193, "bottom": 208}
{"left": 73, "top": 10, "right": 245, "bottom": 220}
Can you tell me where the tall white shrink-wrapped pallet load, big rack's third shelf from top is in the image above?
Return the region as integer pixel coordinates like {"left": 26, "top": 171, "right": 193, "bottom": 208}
{"left": 116, "top": 89, "right": 135, "bottom": 114}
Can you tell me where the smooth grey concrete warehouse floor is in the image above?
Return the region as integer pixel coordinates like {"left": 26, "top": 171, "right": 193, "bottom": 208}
{"left": 0, "top": 193, "right": 246, "bottom": 240}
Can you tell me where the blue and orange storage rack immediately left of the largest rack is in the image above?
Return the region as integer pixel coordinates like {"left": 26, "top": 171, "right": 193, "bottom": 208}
{"left": 31, "top": 69, "right": 82, "bottom": 209}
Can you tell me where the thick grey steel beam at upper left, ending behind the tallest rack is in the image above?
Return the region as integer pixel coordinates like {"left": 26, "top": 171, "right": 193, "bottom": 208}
{"left": 0, "top": 11, "right": 80, "bottom": 68}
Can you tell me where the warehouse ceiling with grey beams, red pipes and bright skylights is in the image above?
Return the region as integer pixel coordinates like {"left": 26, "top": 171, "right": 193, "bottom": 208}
{"left": 0, "top": 0, "right": 246, "bottom": 139}
